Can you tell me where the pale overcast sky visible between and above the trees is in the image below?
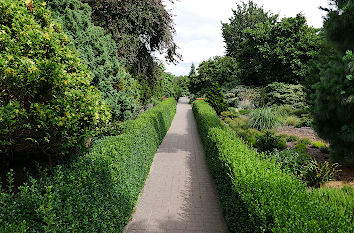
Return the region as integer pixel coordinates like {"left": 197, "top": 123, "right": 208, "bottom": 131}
{"left": 163, "top": 0, "right": 328, "bottom": 75}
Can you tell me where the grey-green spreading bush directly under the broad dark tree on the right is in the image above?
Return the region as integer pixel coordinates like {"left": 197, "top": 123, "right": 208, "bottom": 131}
{"left": 264, "top": 82, "right": 306, "bottom": 108}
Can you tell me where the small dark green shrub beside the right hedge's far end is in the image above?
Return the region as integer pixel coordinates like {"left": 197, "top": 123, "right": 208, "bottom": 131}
{"left": 205, "top": 84, "right": 229, "bottom": 115}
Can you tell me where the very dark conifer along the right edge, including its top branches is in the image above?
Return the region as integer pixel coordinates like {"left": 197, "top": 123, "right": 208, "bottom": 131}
{"left": 312, "top": 0, "right": 354, "bottom": 161}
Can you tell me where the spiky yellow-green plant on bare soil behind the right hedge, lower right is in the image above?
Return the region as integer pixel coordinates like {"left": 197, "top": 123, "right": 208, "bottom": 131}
{"left": 301, "top": 160, "right": 339, "bottom": 188}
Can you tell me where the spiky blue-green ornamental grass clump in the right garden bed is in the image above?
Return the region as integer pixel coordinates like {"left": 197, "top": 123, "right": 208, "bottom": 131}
{"left": 249, "top": 107, "right": 282, "bottom": 130}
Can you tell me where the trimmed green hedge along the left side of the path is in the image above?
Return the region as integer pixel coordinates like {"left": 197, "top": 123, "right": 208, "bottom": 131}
{"left": 0, "top": 98, "right": 176, "bottom": 232}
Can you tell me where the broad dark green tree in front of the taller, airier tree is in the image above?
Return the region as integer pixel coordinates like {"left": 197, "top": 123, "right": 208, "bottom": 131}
{"left": 238, "top": 14, "right": 320, "bottom": 86}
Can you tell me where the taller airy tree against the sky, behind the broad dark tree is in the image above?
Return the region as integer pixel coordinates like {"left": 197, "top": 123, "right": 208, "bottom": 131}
{"left": 222, "top": 1, "right": 278, "bottom": 59}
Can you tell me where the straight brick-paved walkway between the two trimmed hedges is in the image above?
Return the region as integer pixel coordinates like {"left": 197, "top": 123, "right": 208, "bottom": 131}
{"left": 124, "top": 98, "right": 227, "bottom": 233}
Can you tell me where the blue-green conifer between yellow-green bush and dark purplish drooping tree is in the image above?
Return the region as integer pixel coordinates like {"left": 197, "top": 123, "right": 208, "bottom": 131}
{"left": 46, "top": 0, "right": 139, "bottom": 120}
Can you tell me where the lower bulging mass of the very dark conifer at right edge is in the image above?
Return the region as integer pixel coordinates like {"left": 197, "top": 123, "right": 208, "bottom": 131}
{"left": 312, "top": 52, "right": 354, "bottom": 161}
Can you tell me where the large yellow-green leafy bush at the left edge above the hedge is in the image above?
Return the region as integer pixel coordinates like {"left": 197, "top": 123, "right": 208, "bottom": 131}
{"left": 0, "top": 0, "right": 110, "bottom": 157}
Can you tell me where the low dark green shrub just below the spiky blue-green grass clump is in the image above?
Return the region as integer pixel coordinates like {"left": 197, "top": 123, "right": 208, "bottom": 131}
{"left": 255, "top": 131, "right": 286, "bottom": 152}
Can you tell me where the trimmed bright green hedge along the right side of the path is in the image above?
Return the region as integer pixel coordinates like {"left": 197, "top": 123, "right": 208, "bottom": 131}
{"left": 193, "top": 101, "right": 353, "bottom": 232}
